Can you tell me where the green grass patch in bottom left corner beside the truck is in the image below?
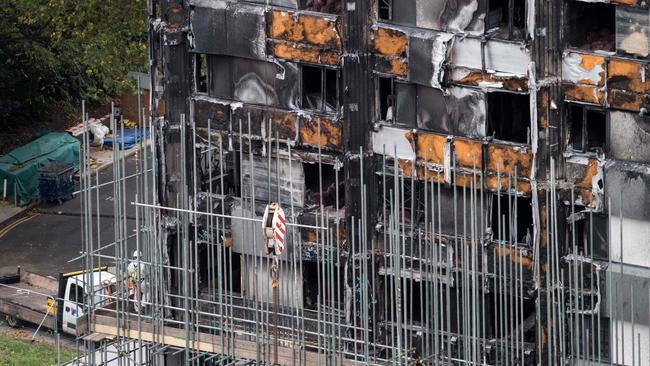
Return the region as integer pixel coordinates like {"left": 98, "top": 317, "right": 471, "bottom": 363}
{"left": 0, "top": 334, "right": 74, "bottom": 366}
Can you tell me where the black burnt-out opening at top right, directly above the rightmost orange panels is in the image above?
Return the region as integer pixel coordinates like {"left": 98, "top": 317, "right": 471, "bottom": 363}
{"left": 564, "top": 0, "right": 616, "bottom": 51}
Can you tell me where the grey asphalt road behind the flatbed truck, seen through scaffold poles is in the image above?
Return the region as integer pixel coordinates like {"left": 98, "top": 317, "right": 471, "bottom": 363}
{"left": 0, "top": 156, "right": 148, "bottom": 276}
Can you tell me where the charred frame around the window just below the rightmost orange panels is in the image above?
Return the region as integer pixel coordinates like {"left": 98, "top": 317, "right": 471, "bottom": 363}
{"left": 564, "top": 103, "right": 609, "bottom": 154}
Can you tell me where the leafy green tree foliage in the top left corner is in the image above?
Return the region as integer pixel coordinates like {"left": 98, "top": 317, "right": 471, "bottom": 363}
{"left": 0, "top": 0, "right": 147, "bottom": 128}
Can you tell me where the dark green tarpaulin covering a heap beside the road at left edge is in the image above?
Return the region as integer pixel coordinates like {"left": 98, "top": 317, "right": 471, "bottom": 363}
{"left": 0, "top": 132, "right": 79, "bottom": 206}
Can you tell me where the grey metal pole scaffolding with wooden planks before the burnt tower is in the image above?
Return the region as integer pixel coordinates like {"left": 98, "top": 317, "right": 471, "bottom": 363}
{"left": 69, "top": 109, "right": 647, "bottom": 365}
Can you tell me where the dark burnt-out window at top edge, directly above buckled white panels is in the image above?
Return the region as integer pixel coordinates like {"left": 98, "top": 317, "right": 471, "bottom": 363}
{"left": 486, "top": 0, "right": 526, "bottom": 39}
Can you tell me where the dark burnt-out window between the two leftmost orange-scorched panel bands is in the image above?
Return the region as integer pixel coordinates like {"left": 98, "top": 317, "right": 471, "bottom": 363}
{"left": 300, "top": 65, "right": 338, "bottom": 113}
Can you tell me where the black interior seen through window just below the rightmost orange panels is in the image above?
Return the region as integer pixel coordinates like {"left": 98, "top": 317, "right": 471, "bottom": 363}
{"left": 567, "top": 104, "right": 607, "bottom": 152}
